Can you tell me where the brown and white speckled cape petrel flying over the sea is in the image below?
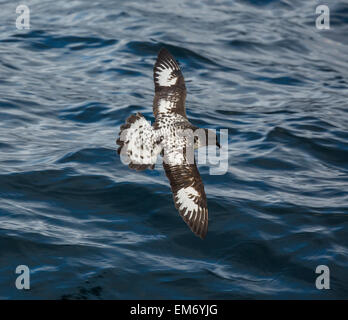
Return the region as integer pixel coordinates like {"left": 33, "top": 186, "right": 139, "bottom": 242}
{"left": 116, "top": 49, "right": 220, "bottom": 239}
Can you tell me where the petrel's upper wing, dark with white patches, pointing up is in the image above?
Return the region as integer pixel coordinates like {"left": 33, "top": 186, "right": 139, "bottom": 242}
{"left": 153, "top": 49, "right": 186, "bottom": 118}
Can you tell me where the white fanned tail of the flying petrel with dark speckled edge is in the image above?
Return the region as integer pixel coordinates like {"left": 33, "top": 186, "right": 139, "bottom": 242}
{"left": 116, "top": 113, "right": 162, "bottom": 170}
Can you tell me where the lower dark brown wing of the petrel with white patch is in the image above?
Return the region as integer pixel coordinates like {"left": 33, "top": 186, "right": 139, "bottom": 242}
{"left": 163, "top": 163, "right": 208, "bottom": 239}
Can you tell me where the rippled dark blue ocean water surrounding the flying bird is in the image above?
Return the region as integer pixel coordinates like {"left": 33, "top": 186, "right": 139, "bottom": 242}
{"left": 0, "top": 0, "right": 348, "bottom": 299}
